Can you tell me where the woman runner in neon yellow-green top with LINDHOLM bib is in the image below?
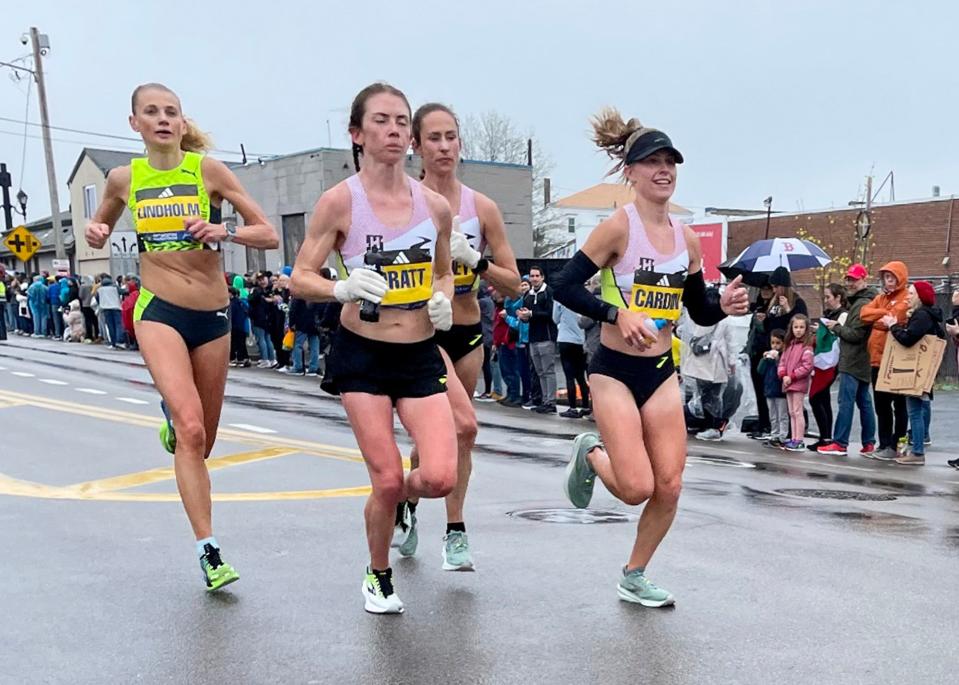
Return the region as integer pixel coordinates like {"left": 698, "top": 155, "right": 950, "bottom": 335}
{"left": 85, "top": 83, "right": 278, "bottom": 590}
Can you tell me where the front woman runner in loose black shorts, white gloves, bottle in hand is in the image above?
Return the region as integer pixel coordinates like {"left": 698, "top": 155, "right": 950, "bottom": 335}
{"left": 292, "top": 83, "right": 456, "bottom": 613}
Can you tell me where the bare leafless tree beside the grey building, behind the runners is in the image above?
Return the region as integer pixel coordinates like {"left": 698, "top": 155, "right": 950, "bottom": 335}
{"left": 460, "top": 110, "right": 569, "bottom": 257}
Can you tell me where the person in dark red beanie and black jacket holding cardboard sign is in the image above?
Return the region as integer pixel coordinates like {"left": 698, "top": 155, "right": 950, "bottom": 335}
{"left": 883, "top": 281, "right": 946, "bottom": 466}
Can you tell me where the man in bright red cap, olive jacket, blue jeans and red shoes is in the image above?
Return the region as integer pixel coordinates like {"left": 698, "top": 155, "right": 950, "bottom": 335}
{"left": 816, "top": 264, "right": 876, "bottom": 458}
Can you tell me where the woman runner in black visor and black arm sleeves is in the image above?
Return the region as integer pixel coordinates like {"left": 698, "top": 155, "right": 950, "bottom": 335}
{"left": 554, "top": 110, "right": 749, "bottom": 607}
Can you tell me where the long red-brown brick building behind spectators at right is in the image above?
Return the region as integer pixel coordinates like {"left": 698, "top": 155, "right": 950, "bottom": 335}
{"left": 727, "top": 197, "right": 959, "bottom": 315}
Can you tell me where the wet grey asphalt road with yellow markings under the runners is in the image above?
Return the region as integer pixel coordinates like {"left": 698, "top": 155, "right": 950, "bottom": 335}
{"left": 0, "top": 337, "right": 959, "bottom": 684}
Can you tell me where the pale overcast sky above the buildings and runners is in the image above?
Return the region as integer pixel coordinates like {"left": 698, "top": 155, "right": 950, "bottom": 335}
{"left": 0, "top": 0, "right": 959, "bottom": 219}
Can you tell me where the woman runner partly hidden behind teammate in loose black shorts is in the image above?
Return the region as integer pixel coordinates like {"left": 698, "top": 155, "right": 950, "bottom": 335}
{"left": 393, "top": 102, "right": 519, "bottom": 571}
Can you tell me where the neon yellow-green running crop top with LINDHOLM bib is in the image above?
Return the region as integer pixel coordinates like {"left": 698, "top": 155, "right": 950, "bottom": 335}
{"left": 127, "top": 152, "right": 220, "bottom": 253}
